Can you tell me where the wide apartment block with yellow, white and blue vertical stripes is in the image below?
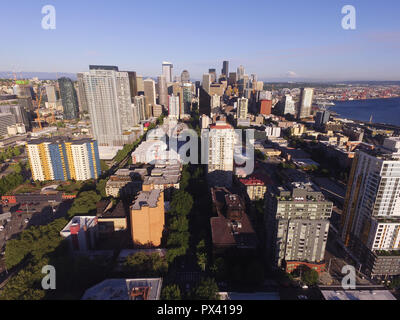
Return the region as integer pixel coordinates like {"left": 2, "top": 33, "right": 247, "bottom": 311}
{"left": 26, "top": 139, "right": 101, "bottom": 181}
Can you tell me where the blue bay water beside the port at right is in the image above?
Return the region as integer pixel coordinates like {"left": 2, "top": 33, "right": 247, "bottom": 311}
{"left": 329, "top": 98, "right": 400, "bottom": 126}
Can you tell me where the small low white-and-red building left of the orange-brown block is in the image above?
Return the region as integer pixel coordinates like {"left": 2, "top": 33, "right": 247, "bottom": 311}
{"left": 60, "top": 216, "right": 99, "bottom": 251}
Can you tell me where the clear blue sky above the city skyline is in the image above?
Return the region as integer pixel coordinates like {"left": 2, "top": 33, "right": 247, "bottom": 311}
{"left": 0, "top": 0, "right": 400, "bottom": 81}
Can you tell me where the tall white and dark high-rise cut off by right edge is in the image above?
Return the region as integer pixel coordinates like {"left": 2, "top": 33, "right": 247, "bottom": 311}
{"left": 341, "top": 137, "right": 400, "bottom": 277}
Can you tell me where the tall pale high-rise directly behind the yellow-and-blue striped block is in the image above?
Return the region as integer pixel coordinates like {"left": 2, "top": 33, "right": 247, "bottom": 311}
{"left": 82, "top": 66, "right": 135, "bottom": 147}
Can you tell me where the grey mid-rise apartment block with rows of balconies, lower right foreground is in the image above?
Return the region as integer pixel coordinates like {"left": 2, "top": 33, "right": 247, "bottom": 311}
{"left": 265, "top": 183, "right": 333, "bottom": 273}
